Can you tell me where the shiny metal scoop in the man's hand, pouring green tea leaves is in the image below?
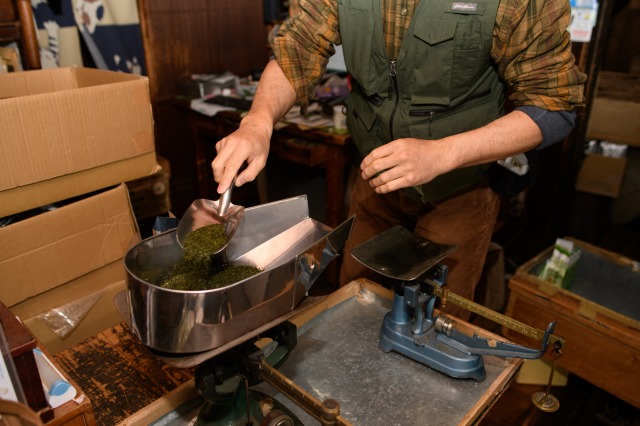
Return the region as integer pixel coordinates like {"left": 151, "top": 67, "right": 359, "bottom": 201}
{"left": 176, "top": 178, "right": 244, "bottom": 254}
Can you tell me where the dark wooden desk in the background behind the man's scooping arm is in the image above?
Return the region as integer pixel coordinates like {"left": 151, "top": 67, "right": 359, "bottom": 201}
{"left": 189, "top": 110, "right": 353, "bottom": 227}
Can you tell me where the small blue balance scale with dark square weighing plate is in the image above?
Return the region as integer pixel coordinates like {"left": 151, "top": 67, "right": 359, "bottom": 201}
{"left": 351, "top": 226, "right": 563, "bottom": 381}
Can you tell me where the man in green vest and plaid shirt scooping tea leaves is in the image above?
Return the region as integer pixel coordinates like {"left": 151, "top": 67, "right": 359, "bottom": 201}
{"left": 212, "top": 0, "right": 586, "bottom": 319}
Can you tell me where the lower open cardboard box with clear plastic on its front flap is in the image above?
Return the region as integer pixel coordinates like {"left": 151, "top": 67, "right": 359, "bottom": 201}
{"left": 0, "top": 184, "right": 140, "bottom": 353}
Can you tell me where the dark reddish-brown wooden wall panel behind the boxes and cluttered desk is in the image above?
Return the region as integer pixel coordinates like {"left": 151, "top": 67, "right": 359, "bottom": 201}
{"left": 138, "top": 0, "right": 269, "bottom": 217}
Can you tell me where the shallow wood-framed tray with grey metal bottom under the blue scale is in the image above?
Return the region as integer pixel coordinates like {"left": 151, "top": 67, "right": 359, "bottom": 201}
{"left": 146, "top": 279, "right": 523, "bottom": 426}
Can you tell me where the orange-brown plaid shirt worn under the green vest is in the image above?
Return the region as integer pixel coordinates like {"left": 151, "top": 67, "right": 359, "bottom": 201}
{"left": 271, "top": 0, "right": 586, "bottom": 111}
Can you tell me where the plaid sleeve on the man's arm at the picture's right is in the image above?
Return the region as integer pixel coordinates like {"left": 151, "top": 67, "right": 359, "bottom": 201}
{"left": 492, "top": 0, "right": 587, "bottom": 111}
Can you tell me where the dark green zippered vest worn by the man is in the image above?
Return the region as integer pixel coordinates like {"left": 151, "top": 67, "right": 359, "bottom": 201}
{"left": 338, "top": 0, "right": 504, "bottom": 202}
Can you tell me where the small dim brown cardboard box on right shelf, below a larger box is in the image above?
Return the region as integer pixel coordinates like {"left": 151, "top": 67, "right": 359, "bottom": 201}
{"left": 576, "top": 154, "right": 627, "bottom": 198}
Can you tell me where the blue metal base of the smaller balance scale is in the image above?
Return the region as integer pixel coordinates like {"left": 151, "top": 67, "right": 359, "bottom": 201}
{"left": 379, "top": 312, "right": 486, "bottom": 382}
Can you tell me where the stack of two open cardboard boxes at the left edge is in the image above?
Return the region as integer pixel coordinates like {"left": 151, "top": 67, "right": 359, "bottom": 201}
{"left": 0, "top": 68, "right": 158, "bottom": 354}
